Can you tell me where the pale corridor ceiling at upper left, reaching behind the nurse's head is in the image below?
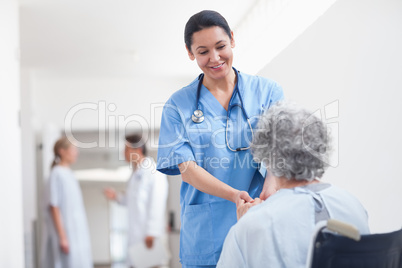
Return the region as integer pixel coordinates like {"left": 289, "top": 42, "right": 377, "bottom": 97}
{"left": 20, "top": 0, "right": 256, "bottom": 78}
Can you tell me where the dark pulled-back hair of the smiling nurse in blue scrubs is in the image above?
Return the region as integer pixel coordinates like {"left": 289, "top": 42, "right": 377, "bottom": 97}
{"left": 184, "top": 10, "right": 232, "bottom": 51}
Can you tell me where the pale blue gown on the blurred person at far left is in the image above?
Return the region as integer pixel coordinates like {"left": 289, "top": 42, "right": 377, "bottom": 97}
{"left": 42, "top": 166, "right": 93, "bottom": 268}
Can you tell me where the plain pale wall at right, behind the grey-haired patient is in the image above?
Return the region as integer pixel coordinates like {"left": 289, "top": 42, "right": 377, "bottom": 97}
{"left": 259, "top": 0, "right": 402, "bottom": 232}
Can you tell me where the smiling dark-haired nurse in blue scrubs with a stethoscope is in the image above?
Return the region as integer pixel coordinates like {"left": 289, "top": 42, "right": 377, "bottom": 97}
{"left": 157, "top": 10, "right": 283, "bottom": 267}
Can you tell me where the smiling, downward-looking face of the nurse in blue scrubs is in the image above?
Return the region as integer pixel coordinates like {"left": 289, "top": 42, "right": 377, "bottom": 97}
{"left": 187, "top": 26, "right": 235, "bottom": 80}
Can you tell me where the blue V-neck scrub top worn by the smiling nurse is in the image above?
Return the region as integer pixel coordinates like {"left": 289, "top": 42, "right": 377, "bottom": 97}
{"left": 157, "top": 69, "right": 283, "bottom": 265}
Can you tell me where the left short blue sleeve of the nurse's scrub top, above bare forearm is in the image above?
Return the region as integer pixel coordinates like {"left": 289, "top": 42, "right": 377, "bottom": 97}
{"left": 157, "top": 101, "right": 195, "bottom": 175}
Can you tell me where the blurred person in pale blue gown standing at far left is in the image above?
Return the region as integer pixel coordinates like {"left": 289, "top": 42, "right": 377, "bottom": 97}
{"left": 42, "top": 137, "right": 93, "bottom": 268}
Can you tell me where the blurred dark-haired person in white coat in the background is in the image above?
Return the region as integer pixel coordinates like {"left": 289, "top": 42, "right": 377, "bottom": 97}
{"left": 104, "top": 134, "right": 169, "bottom": 267}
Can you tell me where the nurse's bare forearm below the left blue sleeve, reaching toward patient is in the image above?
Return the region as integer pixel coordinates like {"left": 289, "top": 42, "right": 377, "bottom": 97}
{"left": 179, "top": 161, "right": 243, "bottom": 203}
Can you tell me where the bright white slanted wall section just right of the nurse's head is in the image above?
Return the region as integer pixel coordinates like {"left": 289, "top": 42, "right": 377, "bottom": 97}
{"left": 234, "top": 0, "right": 336, "bottom": 74}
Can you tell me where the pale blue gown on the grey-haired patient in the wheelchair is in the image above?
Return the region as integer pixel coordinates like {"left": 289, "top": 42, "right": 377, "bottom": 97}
{"left": 217, "top": 186, "right": 369, "bottom": 268}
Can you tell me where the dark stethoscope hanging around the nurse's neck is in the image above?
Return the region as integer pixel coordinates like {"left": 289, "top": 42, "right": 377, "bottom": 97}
{"left": 191, "top": 67, "right": 254, "bottom": 152}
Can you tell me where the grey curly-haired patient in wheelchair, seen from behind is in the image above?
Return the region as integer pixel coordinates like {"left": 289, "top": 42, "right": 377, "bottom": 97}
{"left": 218, "top": 102, "right": 369, "bottom": 268}
